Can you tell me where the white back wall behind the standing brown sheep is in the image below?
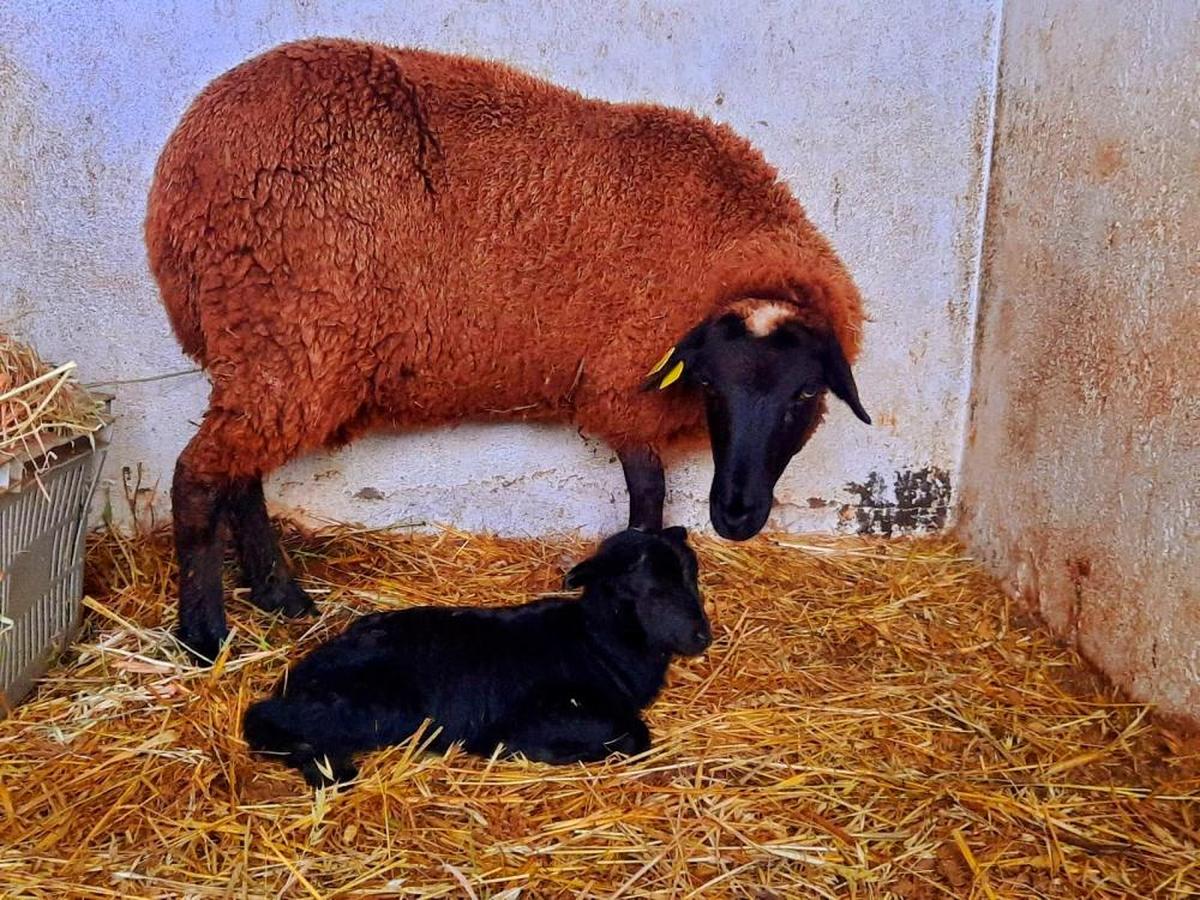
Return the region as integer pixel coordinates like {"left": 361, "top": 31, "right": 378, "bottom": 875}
{"left": 0, "top": 0, "right": 997, "bottom": 533}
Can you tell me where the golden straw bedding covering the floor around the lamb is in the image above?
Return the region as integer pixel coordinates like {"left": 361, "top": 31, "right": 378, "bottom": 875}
{"left": 0, "top": 529, "right": 1200, "bottom": 898}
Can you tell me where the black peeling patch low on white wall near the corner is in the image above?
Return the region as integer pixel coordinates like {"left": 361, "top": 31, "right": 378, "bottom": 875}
{"left": 846, "top": 466, "right": 950, "bottom": 538}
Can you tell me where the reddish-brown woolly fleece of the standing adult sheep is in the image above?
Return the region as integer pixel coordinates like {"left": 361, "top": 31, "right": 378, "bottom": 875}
{"left": 145, "top": 40, "right": 863, "bottom": 476}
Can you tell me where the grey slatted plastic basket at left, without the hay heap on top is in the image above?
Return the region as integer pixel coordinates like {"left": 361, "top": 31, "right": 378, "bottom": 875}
{"left": 0, "top": 412, "right": 108, "bottom": 719}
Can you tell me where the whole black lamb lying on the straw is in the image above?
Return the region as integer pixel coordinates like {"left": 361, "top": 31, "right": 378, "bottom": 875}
{"left": 242, "top": 528, "right": 712, "bottom": 785}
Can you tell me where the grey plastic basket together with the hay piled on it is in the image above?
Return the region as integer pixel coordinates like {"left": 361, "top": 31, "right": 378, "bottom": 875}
{"left": 0, "top": 335, "right": 110, "bottom": 718}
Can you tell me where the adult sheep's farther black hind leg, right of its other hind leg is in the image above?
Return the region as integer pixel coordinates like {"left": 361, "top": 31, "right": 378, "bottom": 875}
{"left": 224, "top": 476, "right": 316, "bottom": 617}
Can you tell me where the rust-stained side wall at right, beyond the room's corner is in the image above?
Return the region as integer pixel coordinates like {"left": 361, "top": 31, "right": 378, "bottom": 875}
{"left": 959, "top": 0, "right": 1200, "bottom": 722}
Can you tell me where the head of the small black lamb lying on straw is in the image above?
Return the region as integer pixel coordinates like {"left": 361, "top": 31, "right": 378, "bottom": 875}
{"left": 565, "top": 527, "right": 713, "bottom": 656}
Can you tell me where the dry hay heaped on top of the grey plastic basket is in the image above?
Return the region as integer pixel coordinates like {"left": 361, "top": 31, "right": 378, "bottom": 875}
{"left": 0, "top": 332, "right": 107, "bottom": 472}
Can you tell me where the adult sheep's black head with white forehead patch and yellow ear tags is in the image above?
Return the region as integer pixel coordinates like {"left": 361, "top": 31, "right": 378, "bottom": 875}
{"left": 644, "top": 301, "right": 871, "bottom": 540}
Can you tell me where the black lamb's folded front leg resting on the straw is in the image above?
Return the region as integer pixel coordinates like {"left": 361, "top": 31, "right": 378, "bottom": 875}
{"left": 477, "top": 695, "right": 650, "bottom": 766}
